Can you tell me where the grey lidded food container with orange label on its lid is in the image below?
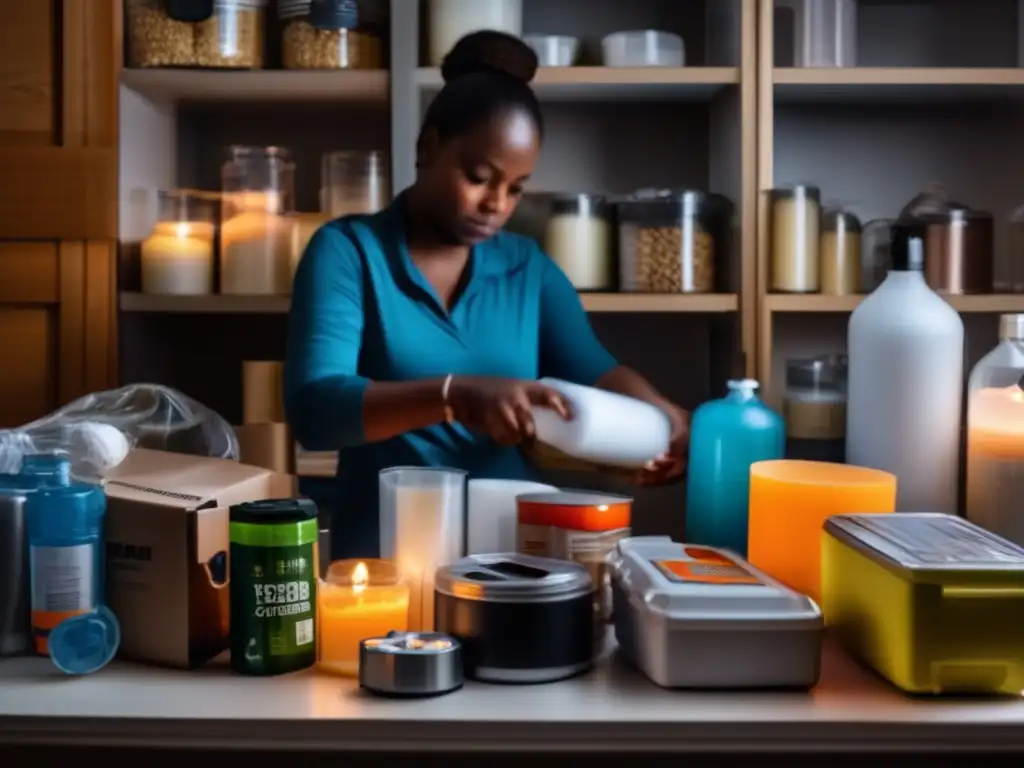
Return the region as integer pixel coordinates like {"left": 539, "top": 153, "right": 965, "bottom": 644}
{"left": 611, "top": 536, "right": 823, "bottom": 688}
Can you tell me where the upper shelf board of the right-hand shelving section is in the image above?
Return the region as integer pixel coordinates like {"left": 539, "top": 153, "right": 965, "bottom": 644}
{"left": 772, "top": 67, "right": 1024, "bottom": 103}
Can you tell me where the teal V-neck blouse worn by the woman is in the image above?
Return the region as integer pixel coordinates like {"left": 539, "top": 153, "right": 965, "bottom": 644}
{"left": 285, "top": 194, "right": 617, "bottom": 559}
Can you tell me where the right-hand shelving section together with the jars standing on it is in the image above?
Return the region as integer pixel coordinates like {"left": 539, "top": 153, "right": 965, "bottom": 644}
{"left": 756, "top": 0, "right": 1024, "bottom": 402}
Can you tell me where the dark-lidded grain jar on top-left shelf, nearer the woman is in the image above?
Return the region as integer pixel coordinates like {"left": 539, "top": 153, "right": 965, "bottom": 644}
{"left": 278, "top": 0, "right": 384, "bottom": 70}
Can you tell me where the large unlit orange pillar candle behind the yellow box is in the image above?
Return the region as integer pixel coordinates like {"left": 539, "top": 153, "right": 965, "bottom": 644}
{"left": 748, "top": 459, "right": 896, "bottom": 600}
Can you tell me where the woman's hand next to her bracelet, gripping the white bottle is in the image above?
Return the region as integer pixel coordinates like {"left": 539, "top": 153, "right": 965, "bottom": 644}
{"left": 447, "top": 376, "right": 572, "bottom": 445}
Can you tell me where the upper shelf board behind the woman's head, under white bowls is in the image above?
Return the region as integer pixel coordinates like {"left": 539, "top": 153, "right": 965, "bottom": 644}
{"left": 416, "top": 67, "right": 739, "bottom": 101}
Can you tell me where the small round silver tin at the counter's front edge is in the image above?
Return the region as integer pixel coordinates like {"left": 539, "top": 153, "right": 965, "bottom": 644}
{"left": 359, "top": 632, "right": 463, "bottom": 697}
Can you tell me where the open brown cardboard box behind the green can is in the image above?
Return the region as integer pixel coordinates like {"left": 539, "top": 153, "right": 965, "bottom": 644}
{"left": 104, "top": 449, "right": 295, "bottom": 669}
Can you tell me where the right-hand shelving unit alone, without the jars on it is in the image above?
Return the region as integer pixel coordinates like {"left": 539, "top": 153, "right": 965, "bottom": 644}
{"left": 756, "top": 0, "right": 1024, "bottom": 403}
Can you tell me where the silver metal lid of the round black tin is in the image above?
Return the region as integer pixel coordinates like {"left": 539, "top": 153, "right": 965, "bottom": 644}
{"left": 434, "top": 552, "right": 594, "bottom": 603}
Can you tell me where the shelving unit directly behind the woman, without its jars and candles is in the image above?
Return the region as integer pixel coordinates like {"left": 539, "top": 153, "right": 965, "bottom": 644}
{"left": 118, "top": 0, "right": 758, "bottom": 529}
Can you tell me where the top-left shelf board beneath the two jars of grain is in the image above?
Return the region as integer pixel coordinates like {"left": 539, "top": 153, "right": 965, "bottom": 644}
{"left": 121, "top": 70, "right": 388, "bottom": 102}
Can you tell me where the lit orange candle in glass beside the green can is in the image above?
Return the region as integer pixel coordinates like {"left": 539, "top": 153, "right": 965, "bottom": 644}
{"left": 316, "top": 560, "right": 409, "bottom": 677}
